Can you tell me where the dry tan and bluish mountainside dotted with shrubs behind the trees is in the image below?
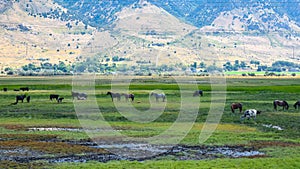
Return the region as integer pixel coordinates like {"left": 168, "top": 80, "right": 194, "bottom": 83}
{"left": 0, "top": 0, "right": 300, "bottom": 69}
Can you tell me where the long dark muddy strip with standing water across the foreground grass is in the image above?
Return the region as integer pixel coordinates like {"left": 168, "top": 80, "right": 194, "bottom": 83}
{"left": 0, "top": 142, "right": 265, "bottom": 163}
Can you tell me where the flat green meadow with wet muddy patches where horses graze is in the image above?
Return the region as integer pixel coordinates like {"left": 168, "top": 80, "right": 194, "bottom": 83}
{"left": 0, "top": 76, "right": 300, "bottom": 168}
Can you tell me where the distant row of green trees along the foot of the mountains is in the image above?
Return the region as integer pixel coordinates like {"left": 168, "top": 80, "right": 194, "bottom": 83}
{"left": 2, "top": 56, "right": 300, "bottom": 76}
